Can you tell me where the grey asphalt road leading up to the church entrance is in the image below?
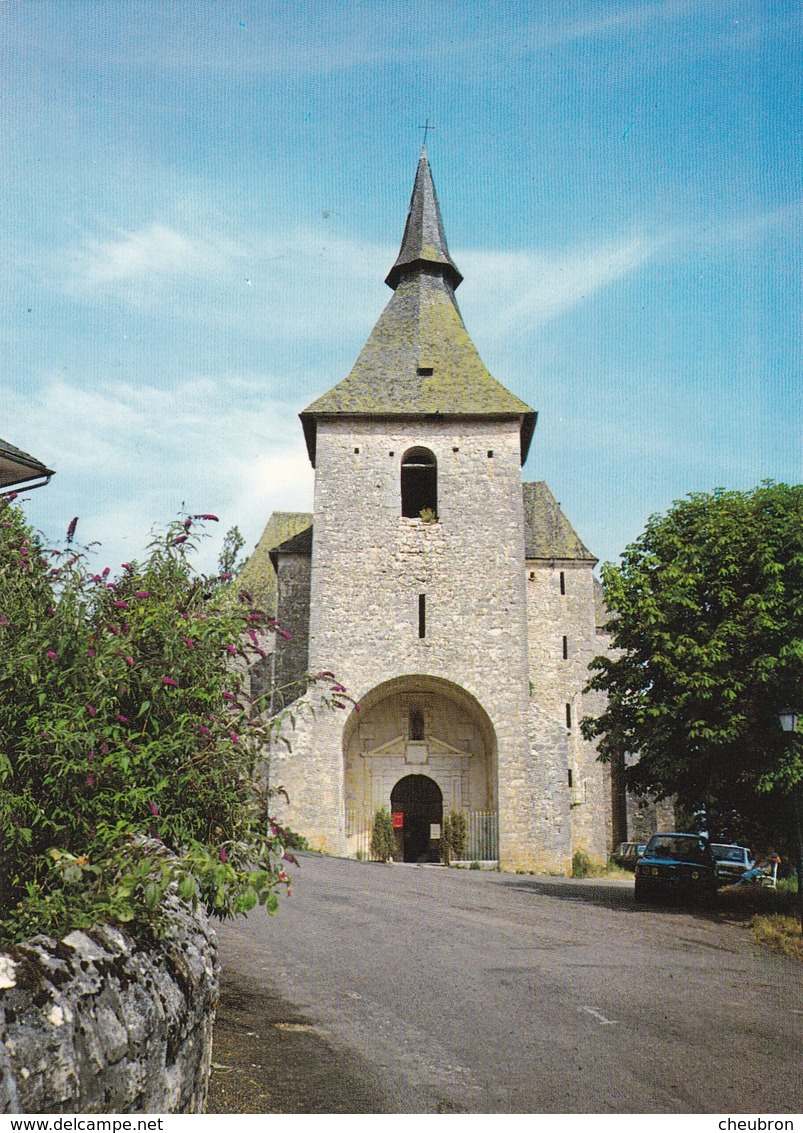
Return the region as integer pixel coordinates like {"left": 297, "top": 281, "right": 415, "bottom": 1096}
{"left": 208, "top": 854, "right": 803, "bottom": 1114}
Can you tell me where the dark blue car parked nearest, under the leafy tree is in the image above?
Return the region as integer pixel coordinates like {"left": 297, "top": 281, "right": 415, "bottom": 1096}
{"left": 635, "top": 832, "right": 717, "bottom": 904}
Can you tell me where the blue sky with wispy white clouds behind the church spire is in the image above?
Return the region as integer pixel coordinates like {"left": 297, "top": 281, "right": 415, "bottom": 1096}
{"left": 0, "top": 0, "right": 803, "bottom": 569}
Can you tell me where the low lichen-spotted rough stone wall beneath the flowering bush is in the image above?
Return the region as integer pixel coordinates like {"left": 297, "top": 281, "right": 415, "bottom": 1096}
{"left": 0, "top": 901, "right": 219, "bottom": 1114}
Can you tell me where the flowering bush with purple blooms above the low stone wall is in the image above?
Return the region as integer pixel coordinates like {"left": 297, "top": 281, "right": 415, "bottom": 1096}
{"left": 0, "top": 500, "right": 344, "bottom": 943}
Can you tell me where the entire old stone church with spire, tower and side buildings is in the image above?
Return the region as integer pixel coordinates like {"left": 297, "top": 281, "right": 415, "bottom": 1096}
{"left": 242, "top": 150, "right": 626, "bottom": 872}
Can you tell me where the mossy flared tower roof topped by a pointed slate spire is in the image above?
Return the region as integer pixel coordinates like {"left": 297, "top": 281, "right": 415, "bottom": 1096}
{"left": 301, "top": 152, "right": 537, "bottom": 465}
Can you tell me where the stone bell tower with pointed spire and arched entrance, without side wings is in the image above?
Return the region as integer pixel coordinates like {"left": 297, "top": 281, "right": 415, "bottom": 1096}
{"left": 266, "top": 143, "right": 573, "bottom": 868}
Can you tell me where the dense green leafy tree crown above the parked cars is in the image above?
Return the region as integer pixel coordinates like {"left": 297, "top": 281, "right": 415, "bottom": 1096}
{"left": 582, "top": 483, "right": 803, "bottom": 837}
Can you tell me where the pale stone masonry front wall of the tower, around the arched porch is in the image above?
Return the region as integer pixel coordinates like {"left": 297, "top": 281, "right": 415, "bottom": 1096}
{"left": 296, "top": 418, "right": 554, "bottom": 868}
